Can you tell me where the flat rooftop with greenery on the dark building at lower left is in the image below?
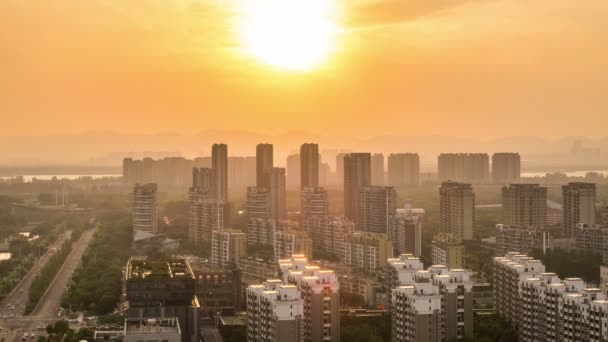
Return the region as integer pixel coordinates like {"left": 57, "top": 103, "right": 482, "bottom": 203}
{"left": 127, "top": 259, "right": 194, "bottom": 279}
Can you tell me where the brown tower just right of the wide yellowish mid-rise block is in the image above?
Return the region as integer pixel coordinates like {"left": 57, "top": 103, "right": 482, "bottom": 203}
{"left": 388, "top": 212, "right": 422, "bottom": 257}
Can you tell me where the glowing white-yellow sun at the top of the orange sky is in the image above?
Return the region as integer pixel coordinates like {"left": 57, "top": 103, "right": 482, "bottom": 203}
{"left": 238, "top": 0, "right": 338, "bottom": 71}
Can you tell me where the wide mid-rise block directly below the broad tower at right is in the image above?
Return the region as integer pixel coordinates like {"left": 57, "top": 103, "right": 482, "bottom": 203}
{"left": 496, "top": 224, "right": 551, "bottom": 255}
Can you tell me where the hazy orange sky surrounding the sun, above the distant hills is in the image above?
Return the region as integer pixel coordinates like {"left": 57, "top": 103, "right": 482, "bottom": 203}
{"left": 0, "top": 0, "right": 608, "bottom": 138}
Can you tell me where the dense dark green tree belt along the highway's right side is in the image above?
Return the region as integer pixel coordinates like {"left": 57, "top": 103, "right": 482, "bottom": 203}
{"left": 62, "top": 212, "right": 133, "bottom": 315}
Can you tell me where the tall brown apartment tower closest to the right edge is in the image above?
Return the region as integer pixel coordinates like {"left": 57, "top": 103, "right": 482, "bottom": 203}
{"left": 562, "top": 182, "right": 596, "bottom": 237}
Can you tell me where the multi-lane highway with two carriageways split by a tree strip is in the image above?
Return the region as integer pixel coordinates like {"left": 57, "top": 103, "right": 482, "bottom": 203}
{"left": 0, "top": 229, "right": 95, "bottom": 341}
